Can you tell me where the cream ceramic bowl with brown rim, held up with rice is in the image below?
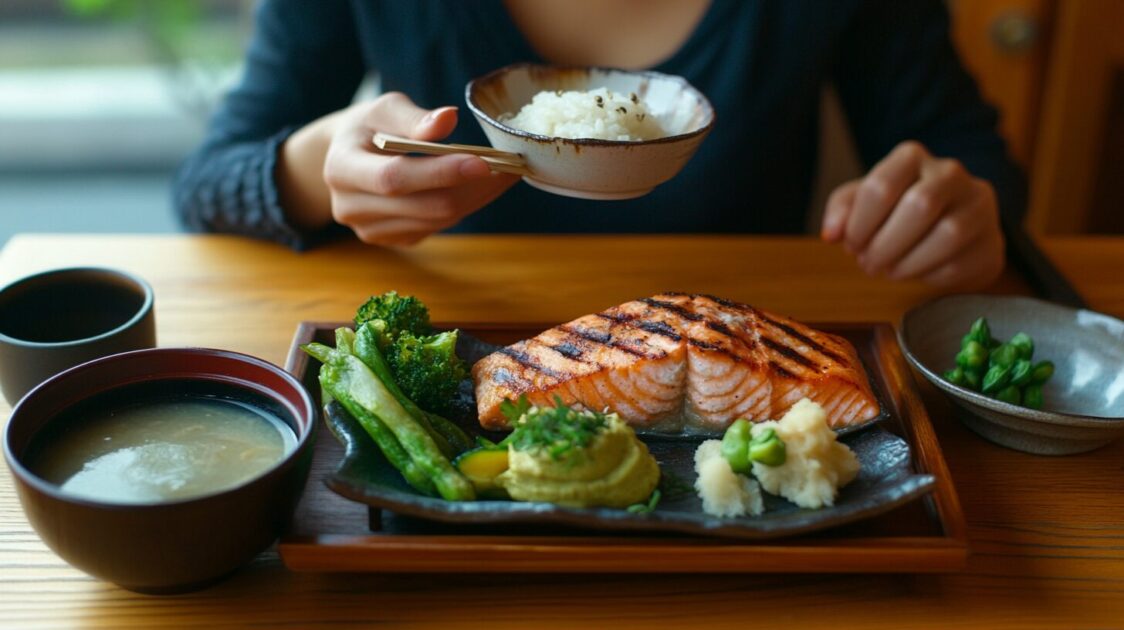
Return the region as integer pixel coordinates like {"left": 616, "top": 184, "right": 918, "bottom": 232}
{"left": 465, "top": 64, "right": 714, "bottom": 199}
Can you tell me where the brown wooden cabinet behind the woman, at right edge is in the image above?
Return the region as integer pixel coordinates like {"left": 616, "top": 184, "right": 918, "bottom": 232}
{"left": 949, "top": 0, "right": 1124, "bottom": 233}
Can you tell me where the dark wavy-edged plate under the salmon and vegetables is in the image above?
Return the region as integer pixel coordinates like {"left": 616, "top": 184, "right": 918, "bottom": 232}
{"left": 314, "top": 333, "right": 936, "bottom": 539}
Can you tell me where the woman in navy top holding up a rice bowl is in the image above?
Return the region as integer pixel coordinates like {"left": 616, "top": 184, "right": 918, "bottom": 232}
{"left": 175, "top": 0, "right": 1025, "bottom": 288}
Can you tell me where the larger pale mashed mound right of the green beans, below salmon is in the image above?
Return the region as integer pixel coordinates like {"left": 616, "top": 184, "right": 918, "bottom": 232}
{"left": 753, "top": 398, "right": 859, "bottom": 509}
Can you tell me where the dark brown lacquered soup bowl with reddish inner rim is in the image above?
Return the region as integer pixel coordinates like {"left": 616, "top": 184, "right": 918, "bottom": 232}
{"left": 3, "top": 349, "right": 316, "bottom": 593}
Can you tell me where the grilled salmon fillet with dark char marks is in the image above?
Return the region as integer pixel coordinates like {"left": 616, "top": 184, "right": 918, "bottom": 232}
{"left": 472, "top": 293, "right": 879, "bottom": 433}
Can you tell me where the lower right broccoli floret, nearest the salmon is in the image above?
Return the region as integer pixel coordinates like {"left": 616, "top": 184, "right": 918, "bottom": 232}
{"left": 387, "top": 331, "right": 469, "bottom": 414}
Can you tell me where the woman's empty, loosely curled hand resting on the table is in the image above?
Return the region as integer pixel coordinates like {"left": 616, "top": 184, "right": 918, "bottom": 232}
{"left": 822, "top": 142, "right": 1004, "bottom": 289}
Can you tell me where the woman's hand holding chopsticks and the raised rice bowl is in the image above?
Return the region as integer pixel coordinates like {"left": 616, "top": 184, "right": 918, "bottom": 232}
{"left": 279, "top": 92, "right": 518, "bottom": 245}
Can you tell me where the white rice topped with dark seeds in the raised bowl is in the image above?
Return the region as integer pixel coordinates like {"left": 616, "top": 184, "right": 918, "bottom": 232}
{"left": 500, "top": 88, "right": 665, "bottom": 142}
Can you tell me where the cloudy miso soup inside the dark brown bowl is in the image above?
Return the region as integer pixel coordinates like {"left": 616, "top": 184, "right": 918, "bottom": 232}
{"left": 31, "top": 384, "right": 297, "bottom": 503}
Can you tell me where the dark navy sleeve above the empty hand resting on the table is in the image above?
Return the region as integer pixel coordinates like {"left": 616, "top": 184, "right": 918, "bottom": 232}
{"left": 835, "top": 0, "right": 1026, "bottom": 226}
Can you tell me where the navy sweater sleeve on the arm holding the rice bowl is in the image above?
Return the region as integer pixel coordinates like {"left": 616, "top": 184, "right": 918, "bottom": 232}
{"left": 172, "top": 0, "right": 364, "bottom": 249}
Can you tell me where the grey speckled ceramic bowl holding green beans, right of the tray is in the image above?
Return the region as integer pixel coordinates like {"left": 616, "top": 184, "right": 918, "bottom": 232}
{"left": 898, "top": 295, "right": 1124, "bottom": 455}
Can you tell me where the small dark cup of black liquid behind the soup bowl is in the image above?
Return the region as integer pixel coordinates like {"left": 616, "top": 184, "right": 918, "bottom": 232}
{"left": 0, "top": 268, "right": 156, "bottom": 405}
